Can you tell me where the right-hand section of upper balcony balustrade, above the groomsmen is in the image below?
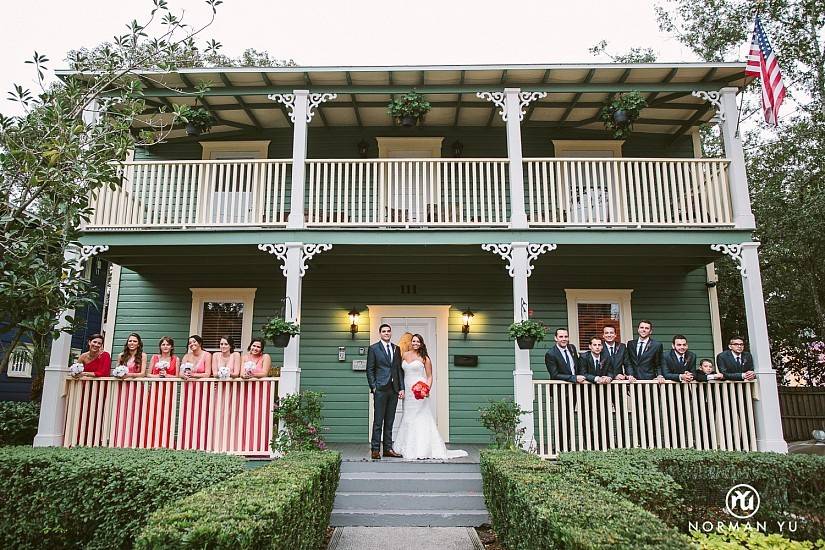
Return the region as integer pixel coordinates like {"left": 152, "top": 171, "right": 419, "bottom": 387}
{"left": 525, "top": 158, "right": 733, "bottom": 227}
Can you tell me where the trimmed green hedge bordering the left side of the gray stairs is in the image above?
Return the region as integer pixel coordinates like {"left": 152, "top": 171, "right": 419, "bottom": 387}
{"left": 136, "top": 452, "right": 341, "bottom": 550}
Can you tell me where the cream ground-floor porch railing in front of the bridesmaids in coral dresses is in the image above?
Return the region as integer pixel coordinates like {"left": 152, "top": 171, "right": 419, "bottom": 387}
{"left": 63, "top": 378, "right": 278, "bottom": 457}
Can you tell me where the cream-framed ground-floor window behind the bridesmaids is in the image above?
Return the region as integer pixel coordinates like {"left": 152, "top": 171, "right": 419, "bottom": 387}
{"left": 189, "top": 288, "right": 256, "bottom": 351}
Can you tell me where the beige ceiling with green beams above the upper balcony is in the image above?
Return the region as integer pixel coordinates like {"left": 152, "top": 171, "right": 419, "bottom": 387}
{"left": 58, "top": 63, "right": 751, "bottom": 138}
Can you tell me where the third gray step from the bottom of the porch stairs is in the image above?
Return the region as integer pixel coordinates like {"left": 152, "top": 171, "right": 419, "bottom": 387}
{"left": 338, "top": 472, "right": 482, "bottom": 493}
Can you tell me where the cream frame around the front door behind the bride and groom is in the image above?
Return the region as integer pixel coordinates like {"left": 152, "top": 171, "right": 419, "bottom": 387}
{"left": 367, "top": 304, "right": 450, "bottom": 442}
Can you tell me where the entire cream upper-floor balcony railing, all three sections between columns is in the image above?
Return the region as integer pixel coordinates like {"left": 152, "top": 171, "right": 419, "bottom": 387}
{"left": 84, "top": 158, "right": 733, "bottom": 230}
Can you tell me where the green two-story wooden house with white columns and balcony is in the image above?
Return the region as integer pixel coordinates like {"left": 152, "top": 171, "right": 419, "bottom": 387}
{"left": 37, "top": 63, "right": 786, "bottom": 456}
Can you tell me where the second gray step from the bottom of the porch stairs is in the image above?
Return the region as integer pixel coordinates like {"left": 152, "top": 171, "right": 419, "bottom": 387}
{"left": 333, "top": 491, "right": 484, "bottom": 512}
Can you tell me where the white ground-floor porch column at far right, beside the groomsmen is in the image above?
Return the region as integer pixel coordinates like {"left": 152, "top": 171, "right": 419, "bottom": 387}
{"left": 741, "top": 242, "right": 788, "bottom": 453}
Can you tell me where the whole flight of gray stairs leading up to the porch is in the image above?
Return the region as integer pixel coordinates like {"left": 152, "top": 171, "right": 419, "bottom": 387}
{"left": 330, "top": 460, "right": 489, "bottom": 527}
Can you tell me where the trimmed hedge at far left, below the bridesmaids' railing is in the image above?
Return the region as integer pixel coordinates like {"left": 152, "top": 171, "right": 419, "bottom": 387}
{"left": 0, "top": 447, "right": 244, "bottom": 549}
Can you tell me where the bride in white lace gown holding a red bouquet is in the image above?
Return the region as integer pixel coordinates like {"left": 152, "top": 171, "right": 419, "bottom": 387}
{"left": 394, "top": 334, "right": 467, "bottom": 459}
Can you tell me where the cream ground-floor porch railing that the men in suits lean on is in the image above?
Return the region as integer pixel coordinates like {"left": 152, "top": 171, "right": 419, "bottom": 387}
{"left": 533, "top": 380, "right": 758, "bottom": 458}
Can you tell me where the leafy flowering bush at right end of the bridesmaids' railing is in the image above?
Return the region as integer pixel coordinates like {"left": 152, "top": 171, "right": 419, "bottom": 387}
{"left": 272, "top": 390, "right": 326, "bottom": 454}
